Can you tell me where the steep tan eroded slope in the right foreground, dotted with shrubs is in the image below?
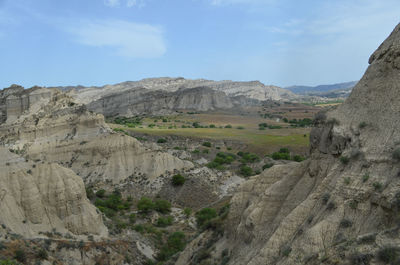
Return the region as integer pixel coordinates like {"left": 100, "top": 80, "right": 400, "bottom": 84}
{"left": 177, "top": 24, "right": 400, "bottom": 265}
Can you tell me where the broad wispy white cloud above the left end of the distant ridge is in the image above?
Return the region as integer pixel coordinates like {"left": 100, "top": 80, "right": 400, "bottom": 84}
{"left": 68, "top": 20, "right": 167, "bottom": 58}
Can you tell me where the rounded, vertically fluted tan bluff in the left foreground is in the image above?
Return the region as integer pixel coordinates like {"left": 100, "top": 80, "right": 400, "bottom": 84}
{"left": 0, "top": 148, "right": 107, "bottom": 237}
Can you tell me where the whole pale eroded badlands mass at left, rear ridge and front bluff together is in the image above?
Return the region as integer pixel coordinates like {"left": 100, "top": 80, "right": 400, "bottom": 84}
{"left": 0, "top": 86, "right": 193, "bottom": 237}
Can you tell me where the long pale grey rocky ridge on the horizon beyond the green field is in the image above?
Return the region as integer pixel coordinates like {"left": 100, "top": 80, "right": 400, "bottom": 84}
{"left": 62, "top": 78, "right": 296, "bottom": 116}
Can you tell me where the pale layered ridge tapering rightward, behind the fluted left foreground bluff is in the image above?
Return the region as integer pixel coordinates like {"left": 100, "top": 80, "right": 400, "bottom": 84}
{"left": 0, "top": 85, "right": 192, "bottom": 183}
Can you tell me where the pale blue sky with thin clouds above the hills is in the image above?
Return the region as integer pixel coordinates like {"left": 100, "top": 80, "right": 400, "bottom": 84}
{"left": 0, "top": 0, "right": 400, "bottom": 88}
